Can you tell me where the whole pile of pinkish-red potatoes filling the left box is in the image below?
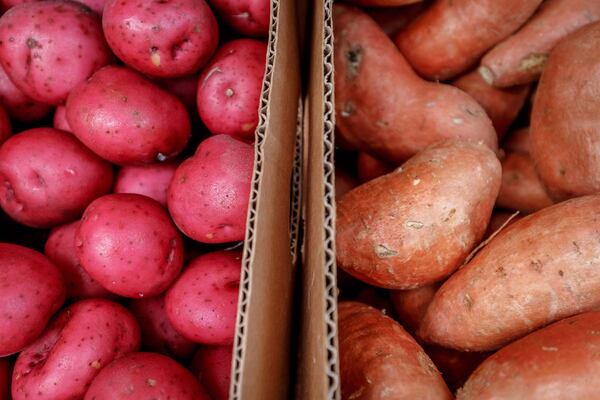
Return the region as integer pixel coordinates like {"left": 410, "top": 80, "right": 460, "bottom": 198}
{"left": 0, "top": 0, "right": 270, "bottom": 400}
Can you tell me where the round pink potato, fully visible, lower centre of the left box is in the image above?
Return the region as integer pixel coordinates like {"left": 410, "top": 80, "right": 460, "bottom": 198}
{"left": 75, "top": 194, "right": 183, "bottom": 298}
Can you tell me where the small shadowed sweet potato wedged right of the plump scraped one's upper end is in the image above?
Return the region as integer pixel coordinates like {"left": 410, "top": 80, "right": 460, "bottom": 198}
{"left": 496, "top": 152, "right": 554, "bottom": 213}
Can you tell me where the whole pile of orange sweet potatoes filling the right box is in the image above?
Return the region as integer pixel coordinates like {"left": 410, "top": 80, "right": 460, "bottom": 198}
{"left": 333, "top": 0, "right": 600, "bottom": 400}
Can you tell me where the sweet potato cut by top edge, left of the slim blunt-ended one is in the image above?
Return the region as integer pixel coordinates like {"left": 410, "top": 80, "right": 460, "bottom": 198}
{"left": 395, "top": 0, "right": 542, "bottom": 80}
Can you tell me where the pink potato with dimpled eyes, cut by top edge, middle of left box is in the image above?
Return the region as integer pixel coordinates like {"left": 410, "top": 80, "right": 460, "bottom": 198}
{"left": 102, "top": 0, "right": 219, "bottom": 78}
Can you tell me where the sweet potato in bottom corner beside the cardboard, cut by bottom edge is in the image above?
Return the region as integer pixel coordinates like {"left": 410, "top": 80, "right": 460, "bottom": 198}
{"left": 338, "top": 302, "right": 452, "bottom": 400}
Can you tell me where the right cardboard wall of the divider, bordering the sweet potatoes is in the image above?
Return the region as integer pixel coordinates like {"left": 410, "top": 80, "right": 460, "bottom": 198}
{"left": 295, "top": 0, "right": 340, "bottom": 400}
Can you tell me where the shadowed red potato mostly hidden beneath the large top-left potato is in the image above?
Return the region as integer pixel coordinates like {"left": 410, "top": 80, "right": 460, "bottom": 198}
{"left": 0, "top": 66, "right": 51, "bottom": 122}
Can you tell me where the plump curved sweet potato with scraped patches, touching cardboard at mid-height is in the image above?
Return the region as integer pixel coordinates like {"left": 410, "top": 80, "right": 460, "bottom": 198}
{"left": 336, "top": 140, "right": 501, "bottom": 289}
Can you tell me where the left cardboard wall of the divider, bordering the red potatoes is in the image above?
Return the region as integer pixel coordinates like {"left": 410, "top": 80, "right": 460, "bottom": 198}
{"left": 230, "top": 0, "right": 302, "bottom": 400}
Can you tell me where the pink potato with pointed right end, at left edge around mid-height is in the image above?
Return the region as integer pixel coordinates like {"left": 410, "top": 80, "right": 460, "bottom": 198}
{"left": 0, "top": 128, "right": 113, "bottom": 228}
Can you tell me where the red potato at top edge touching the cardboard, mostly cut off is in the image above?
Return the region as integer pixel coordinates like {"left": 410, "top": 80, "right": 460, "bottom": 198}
{"left": 210, "top": 0, "right": 271, "bottom": 36}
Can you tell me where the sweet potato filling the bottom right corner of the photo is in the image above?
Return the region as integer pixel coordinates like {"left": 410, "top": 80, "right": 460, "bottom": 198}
{"left": 457, "top": 312, "right": 600, "bottom": 400}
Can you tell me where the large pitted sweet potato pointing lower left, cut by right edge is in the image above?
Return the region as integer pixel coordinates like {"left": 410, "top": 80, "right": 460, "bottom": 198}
{"left": 418, "top": 195, "right": 600, "bottom": 351}
